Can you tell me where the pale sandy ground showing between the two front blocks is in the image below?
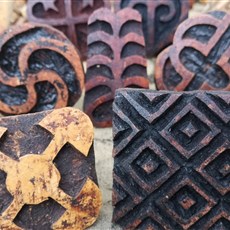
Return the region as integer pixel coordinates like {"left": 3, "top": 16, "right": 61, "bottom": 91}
{"left": 74, "top": 91, "right": 120, "bottom": 230}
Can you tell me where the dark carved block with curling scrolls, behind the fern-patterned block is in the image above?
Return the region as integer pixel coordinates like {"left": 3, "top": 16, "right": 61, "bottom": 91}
{"left": 115, "top": 0, "right": 189, "bottom": 58}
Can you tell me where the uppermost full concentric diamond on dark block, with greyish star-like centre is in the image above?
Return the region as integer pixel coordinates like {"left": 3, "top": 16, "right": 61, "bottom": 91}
{"left": 160, "top": 104, "right": 220, "bottom": 158}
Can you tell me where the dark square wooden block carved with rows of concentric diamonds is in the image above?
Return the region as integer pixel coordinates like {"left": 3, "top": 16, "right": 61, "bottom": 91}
{"left": 113, "top": 89, "right": 230, "bottom": 230}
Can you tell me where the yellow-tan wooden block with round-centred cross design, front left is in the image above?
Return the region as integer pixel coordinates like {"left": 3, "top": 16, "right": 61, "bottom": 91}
{"left": 0, "top": 108, "right": 101, "bottom": 229}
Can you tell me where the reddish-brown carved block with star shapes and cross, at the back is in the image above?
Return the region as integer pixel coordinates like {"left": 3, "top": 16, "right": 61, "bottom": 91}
{"left": 27, "top": 0, "right": 110, "bottom": 60}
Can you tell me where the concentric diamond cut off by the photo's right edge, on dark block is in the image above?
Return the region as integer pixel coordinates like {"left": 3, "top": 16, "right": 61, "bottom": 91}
{"left": 197, "top": 146, "right": 230, "bottom": 195}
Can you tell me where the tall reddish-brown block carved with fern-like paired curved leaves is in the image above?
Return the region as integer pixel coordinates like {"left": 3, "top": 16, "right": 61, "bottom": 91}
{"left": 84, "top": 8, "right": 149, "bottom": 127}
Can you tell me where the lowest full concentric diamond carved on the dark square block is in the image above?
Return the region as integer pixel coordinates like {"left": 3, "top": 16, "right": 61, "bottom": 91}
{"left": 157, "top": 178, "right": 215, "bottom": 229}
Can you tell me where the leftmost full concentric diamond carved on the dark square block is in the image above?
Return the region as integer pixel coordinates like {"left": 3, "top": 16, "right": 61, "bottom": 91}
{"left": 122, "top": 140, "right": 178, "bottom": 192}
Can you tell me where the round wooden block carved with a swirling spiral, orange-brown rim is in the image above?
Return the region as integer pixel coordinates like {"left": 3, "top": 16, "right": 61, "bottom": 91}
{"left": 0, "top": 24, "right": 84, "bottom": 114}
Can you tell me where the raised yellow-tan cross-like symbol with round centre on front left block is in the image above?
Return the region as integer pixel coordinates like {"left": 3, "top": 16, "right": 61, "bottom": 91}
{"left": 0, "top": 108, "right": 101, "bottom": 229}
